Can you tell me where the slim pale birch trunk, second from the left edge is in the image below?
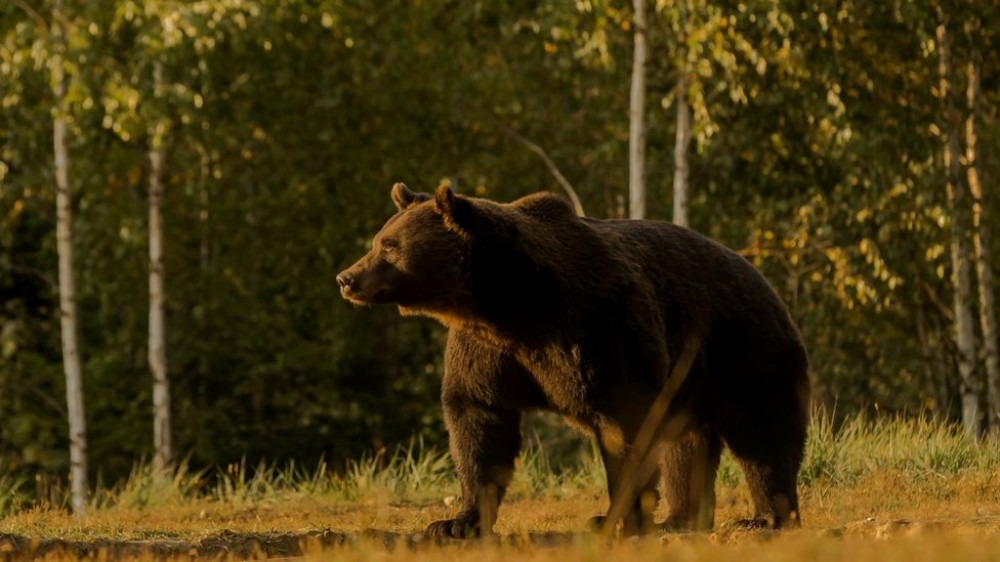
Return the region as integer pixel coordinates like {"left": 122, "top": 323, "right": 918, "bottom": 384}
{"left": 149, "top": 61, "right": 173, "bottom": 477}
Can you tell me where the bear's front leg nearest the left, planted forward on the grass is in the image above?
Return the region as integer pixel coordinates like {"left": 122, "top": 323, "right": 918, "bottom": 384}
{"left": 427, "top": 334, "right": 525, "bottom": 538}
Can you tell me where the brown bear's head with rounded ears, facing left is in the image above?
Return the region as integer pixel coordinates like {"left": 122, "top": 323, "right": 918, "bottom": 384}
{"left": 337, "top": 183, "right": 473, "bottom": 315}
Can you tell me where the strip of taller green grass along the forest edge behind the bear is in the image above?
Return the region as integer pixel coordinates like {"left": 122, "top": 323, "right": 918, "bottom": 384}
{"left": 0, "top": 414, "right": 1000, "bottom": 515}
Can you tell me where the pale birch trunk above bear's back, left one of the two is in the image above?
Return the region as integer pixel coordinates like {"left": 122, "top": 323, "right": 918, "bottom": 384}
{"left": 628, "top": 0, "right": 646, "bottom": 219}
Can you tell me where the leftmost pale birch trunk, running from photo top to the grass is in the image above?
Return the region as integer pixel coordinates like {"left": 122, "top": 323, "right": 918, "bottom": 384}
{"left": 50, "top": 0, "right": 88, "bottom": 515}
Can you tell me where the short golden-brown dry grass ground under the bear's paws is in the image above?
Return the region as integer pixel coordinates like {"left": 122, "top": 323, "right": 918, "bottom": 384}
{"left": 0, "top": 468, "right": 1000, "bottom": 562}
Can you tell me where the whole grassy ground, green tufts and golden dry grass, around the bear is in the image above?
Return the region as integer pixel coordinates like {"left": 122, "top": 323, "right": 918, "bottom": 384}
{"left": 0, "top": 417, "right": 1000, "bottom": 562}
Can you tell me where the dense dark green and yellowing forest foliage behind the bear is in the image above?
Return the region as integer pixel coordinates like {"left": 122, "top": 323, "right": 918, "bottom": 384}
{"left": 0, "top": 0, "right": 1000, "bottom": 492}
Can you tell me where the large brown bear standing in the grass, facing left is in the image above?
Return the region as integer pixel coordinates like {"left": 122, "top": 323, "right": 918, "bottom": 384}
{"left": 337, "top": 184, "right": 809, "bottom": 537}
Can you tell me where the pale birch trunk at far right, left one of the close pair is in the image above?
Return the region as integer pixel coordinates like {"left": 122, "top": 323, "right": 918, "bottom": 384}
{"left": 937, "top": 17, "right": 980, "bottom": 439}
